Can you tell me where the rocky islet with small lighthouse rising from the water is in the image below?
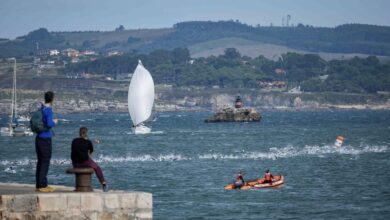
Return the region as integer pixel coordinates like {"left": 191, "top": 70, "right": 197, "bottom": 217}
{"left": 205, "top": 96, "right": 261, "bottom": 122}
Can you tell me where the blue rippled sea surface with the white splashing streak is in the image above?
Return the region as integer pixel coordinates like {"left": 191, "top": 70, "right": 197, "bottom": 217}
{"left": 0, "top": 111, "right": 390, "bottom": 219}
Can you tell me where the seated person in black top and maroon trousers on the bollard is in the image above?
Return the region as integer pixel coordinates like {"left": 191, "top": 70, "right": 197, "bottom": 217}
{"left": 71, "top": 127, "right": 108, "bottom": 192}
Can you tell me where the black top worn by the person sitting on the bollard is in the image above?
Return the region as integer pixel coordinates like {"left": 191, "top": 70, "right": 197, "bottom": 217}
{"left": 71, "top": 138, "right": 93, "bottom": 164}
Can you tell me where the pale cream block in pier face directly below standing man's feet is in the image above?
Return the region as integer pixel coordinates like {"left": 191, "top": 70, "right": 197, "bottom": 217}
{"left": 38, "top": 193, "right": 68, "bottom": 211}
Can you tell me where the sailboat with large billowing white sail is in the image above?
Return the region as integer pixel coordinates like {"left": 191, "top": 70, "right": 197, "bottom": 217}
{"left": 127, "top": 60, "right": 154, "bottom": 134}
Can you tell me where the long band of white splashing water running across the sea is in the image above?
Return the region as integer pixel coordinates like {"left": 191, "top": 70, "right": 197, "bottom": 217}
{"left": 0, "top": 146, "right": 388, "bottom": 173}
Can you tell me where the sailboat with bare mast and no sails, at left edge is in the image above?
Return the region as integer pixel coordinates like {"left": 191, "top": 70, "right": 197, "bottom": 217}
{"left": 0, "top": 58, "right": 33, "bottom": 136}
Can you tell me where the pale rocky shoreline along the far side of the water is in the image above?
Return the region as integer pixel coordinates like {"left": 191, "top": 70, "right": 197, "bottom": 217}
{"left": 0, "top": 90, "right": 390, "bottom": 114}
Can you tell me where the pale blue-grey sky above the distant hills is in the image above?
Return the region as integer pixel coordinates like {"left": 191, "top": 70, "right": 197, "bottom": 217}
{"left": 0, "top": 0, "right": 390, "bottom": 39}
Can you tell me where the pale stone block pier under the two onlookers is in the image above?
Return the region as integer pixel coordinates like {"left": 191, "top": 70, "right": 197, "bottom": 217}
{"left": 0, "top": 183, "right": 153, "bottom": 220}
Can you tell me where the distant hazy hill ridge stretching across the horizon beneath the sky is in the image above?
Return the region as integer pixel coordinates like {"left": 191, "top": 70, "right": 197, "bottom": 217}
{"left": 0, "top": 21, "right": 390, "bottom": 58}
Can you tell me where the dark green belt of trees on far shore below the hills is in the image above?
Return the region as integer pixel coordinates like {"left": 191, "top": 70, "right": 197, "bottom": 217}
{"left": 62, "top": 48, "right": 390, "bottom": 93}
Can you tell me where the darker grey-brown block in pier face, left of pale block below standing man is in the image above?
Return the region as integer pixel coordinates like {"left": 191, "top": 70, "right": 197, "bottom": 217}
{"left": 7, "top": 195, "right": 38, "bottom": 212}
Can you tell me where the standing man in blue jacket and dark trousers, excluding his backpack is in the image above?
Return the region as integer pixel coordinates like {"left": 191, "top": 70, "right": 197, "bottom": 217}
{"left": 35, "top": 91, "right": 58, "bottom": 192}
